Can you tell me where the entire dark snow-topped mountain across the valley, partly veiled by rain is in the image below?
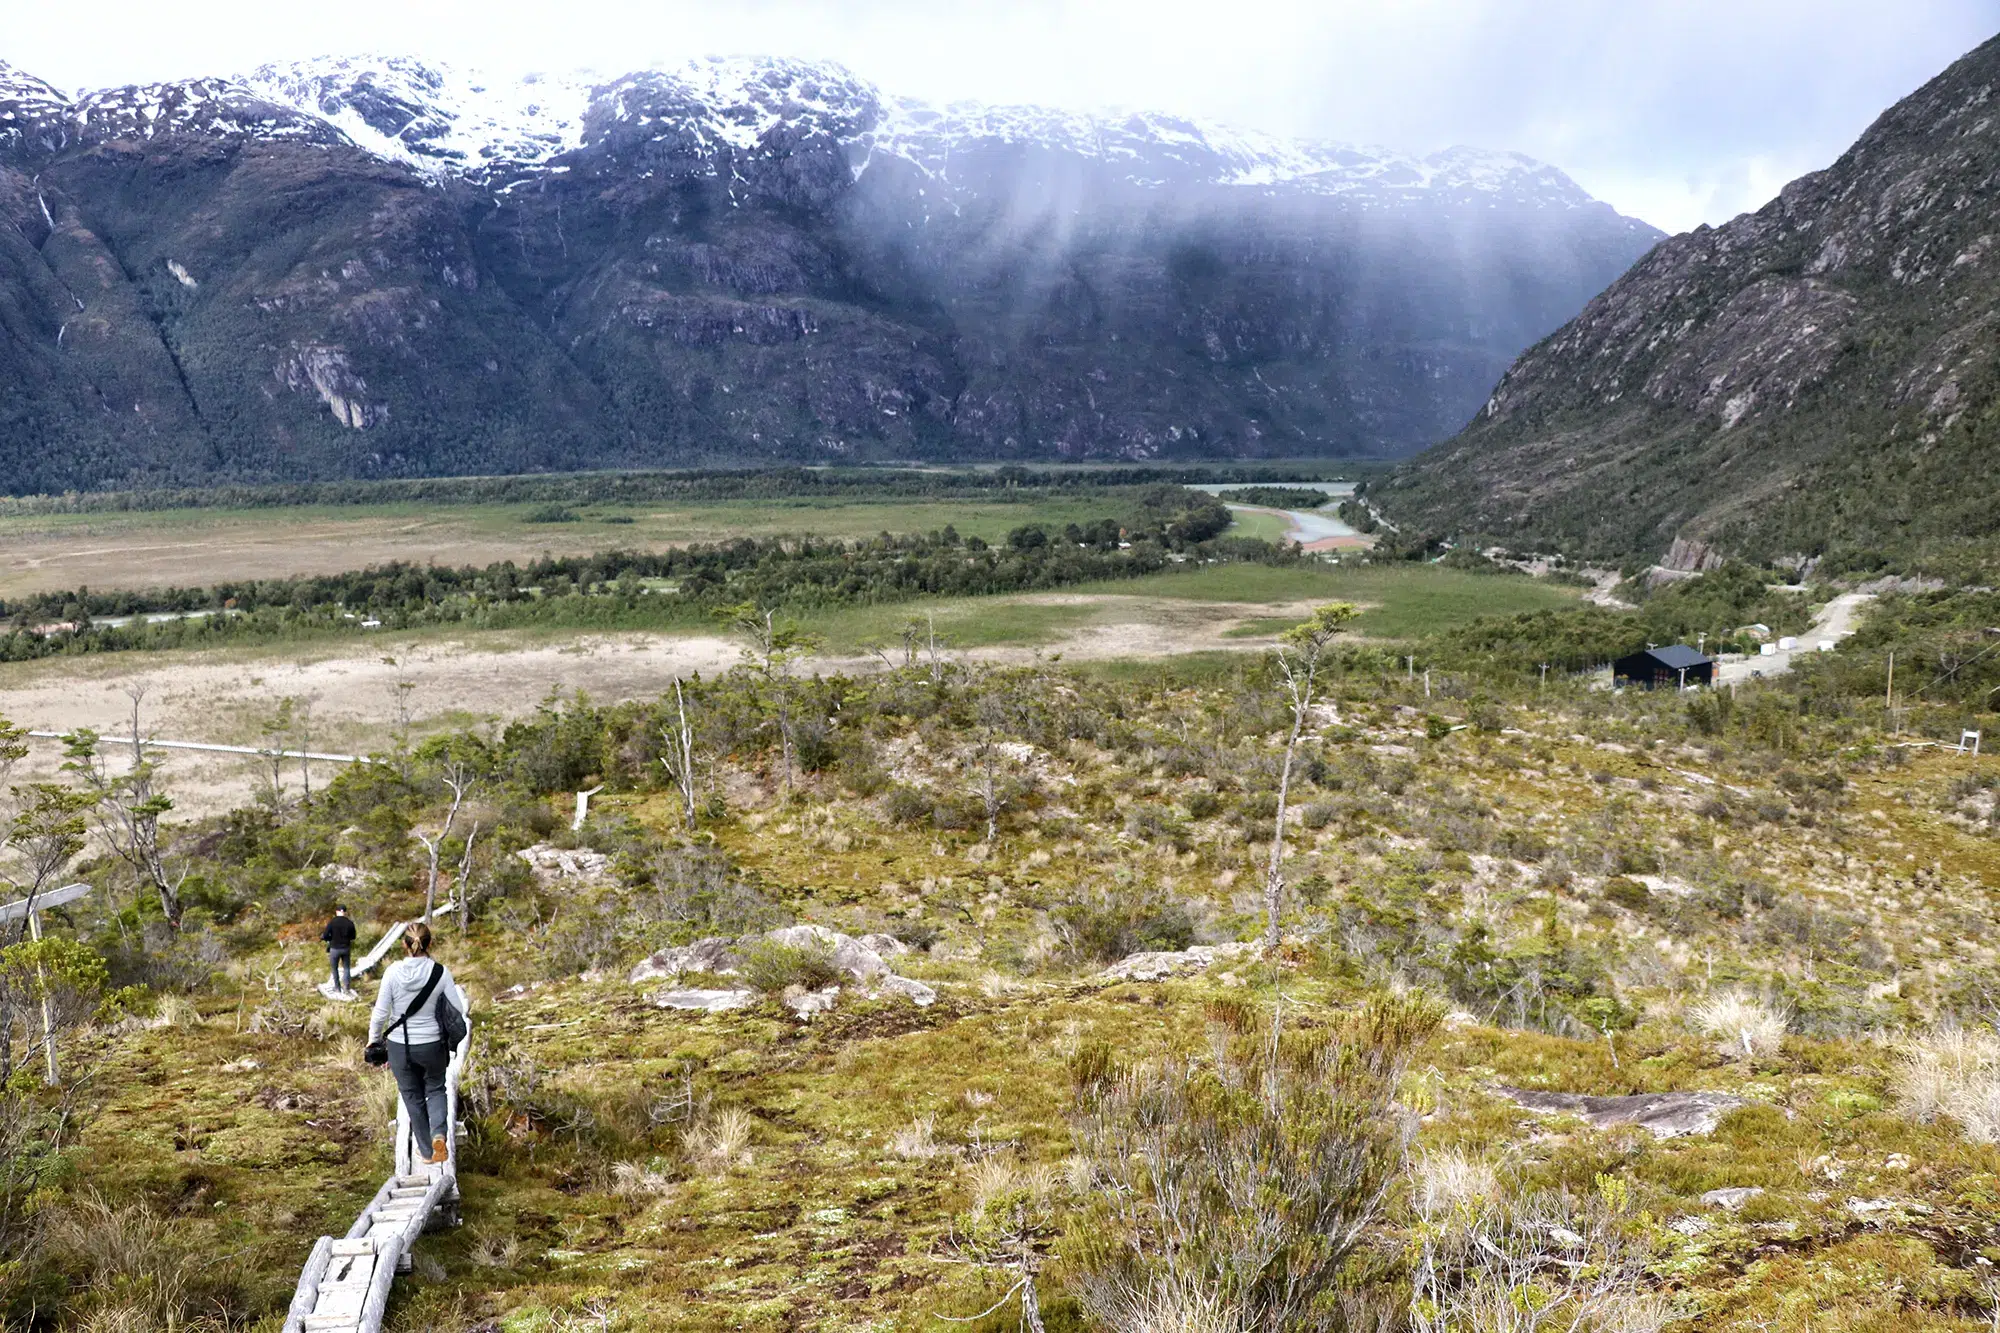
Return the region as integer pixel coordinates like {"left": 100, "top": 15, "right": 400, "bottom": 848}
{"left": 0, "top": 60, "right": 1656, "bottom": 490}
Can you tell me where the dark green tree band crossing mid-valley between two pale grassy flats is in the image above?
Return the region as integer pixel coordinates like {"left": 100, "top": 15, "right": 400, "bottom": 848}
{"left": 0, "top": 486, "right": 1298, "bottom": 660}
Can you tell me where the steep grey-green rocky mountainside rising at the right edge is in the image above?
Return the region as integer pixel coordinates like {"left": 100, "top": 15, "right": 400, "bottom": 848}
{"left": 1378, "top": 38, "right": 2000, "bottom": 554}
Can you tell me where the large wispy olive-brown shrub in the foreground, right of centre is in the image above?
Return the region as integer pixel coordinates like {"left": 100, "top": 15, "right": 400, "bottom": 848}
{"left": 1070, "top": 995, "right": 1438, "bottom": 1333}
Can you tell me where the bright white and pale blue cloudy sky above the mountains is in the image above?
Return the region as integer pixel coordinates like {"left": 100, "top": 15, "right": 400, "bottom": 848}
{"left": 0, "top": 0, "right": 2000, "bottom": 230}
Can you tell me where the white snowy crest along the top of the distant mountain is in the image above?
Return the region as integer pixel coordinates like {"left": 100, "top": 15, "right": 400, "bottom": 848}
{"left": 199, "top": 56, "right": 1592, "bottom": 208}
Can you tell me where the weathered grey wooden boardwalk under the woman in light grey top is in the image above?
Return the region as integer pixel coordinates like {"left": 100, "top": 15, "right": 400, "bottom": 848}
{"left": 284, "top": 976, "right": 472, "bottom": 1333}
